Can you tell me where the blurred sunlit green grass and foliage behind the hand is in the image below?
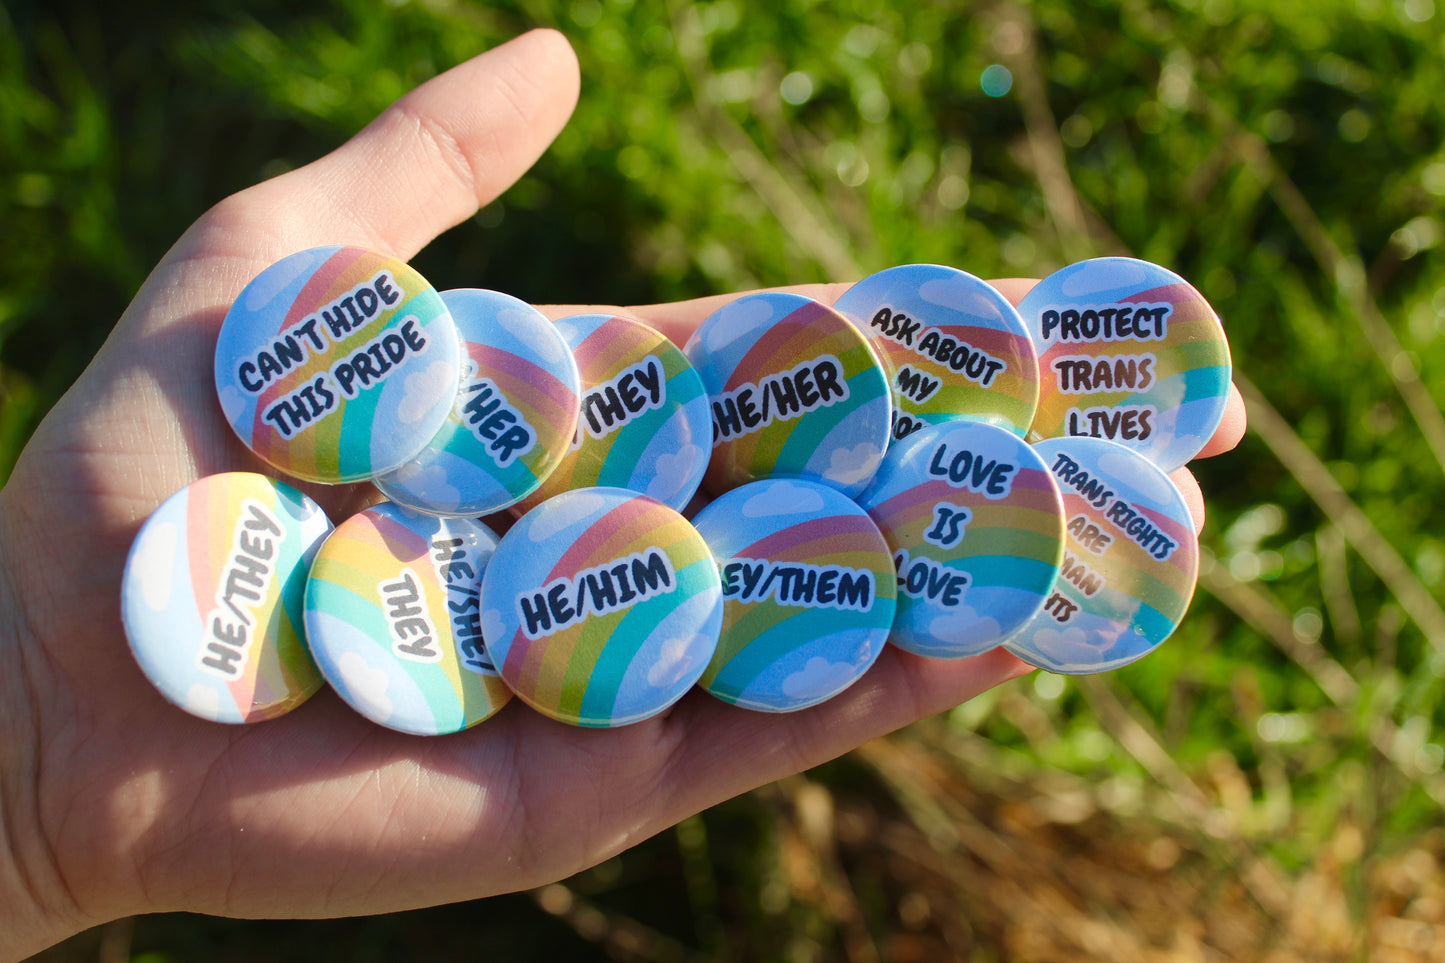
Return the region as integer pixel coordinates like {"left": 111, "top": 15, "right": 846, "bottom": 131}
{"left": 8, "top": 0, "right": 1445, "bottom": 960}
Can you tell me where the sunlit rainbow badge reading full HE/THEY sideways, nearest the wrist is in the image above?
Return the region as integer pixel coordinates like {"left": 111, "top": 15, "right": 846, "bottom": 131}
{"left": 121, "top": 471, "right": 331, "bottom": 723}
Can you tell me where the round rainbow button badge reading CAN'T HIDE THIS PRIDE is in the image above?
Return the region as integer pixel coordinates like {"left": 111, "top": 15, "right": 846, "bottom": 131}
{"left": 215, "top": 247, "right": 460, "bottom": 483}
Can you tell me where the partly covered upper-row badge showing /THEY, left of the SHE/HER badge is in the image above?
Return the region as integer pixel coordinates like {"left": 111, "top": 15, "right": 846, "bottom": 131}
{"left": 513, "top": 314, "right": 712, "bottom": 516}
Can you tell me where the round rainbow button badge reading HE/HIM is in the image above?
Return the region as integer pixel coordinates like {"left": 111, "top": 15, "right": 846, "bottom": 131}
{"left": 481, "top": 487, "right": 723, "bottom": 727}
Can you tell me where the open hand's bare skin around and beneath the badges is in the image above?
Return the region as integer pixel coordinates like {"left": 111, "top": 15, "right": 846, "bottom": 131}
{"left": 0, "top": 30, "right": 1244, "bottom": 960}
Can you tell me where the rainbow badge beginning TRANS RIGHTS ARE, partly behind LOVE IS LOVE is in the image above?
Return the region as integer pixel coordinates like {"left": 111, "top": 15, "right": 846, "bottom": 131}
{"left": 1004, "top": 438, "right": 1199, "bottom": 674}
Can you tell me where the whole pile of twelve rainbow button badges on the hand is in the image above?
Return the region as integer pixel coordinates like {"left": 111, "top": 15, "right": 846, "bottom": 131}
{"left": 123, "top": 247, "right": 1230, "bottom": 735}
